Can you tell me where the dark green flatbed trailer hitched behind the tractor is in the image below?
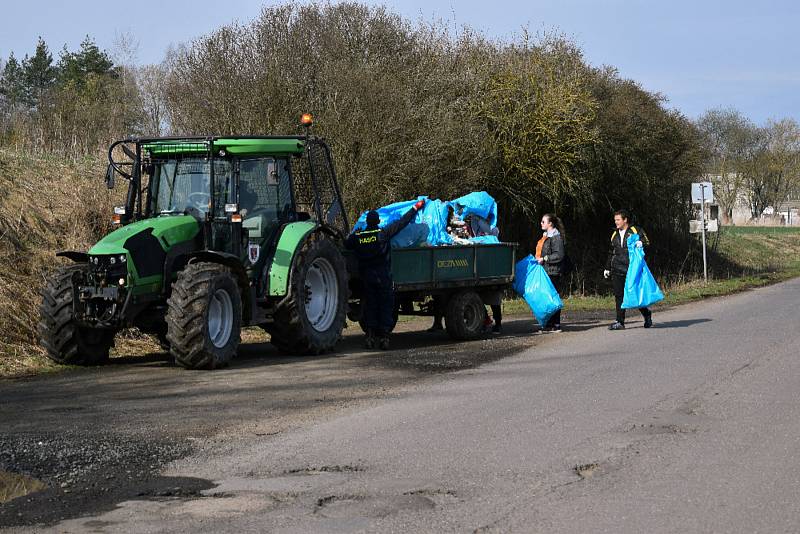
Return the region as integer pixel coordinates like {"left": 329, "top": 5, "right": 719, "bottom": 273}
{"left": 350, "top": 243, "right": 517, "bottom": 340}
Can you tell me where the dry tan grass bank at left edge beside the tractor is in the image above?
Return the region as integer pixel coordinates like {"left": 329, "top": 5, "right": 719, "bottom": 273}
{"left": 0, "top": 149, "right": 121, "bottom": 376}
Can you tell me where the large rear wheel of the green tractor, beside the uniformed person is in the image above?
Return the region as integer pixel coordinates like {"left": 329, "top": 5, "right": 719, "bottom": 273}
{"left": 266, "top": 233, "right": 348, "bottom": 355}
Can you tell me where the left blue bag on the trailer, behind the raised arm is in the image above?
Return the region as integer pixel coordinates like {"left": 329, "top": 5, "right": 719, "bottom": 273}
{"left": 353, "top": 196, "right": 453, "bottom": 248}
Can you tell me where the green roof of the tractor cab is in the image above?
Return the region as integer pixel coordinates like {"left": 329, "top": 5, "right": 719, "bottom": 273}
{"left": 140, "top": 136, "right": 305, "bottom": 157}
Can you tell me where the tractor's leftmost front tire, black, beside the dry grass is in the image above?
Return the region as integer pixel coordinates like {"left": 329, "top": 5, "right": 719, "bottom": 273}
{"left": 37, "top": 264, "right": 116, "bottom": 365}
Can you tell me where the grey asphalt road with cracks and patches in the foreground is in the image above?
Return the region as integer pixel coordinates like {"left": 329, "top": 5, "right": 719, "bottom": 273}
{"left": 0, "top": 280, "right": 800, "bottom": 533}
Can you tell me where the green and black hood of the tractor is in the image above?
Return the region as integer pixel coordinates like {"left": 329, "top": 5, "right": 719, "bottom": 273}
{"left": 89, "top": 215, "right": 200, "bottom": 256}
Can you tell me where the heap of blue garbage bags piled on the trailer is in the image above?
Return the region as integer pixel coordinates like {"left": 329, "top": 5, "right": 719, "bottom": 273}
{"left": 353, "top": 191, "right": 500, "bottom": 248}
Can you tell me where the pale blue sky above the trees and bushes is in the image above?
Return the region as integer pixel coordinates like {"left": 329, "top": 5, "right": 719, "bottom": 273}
{"left": 0, "top": 0, "right": 800, "bottom": 123}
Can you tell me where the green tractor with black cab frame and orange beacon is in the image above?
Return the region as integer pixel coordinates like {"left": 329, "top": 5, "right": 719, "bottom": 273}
{"left": 38, "top": 126, "right": 349, "bottom": 369}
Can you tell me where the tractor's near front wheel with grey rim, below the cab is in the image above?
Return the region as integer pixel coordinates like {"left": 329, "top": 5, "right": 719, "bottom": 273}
{"left": 166, "top": 262, "right": 242, "bottom": 369}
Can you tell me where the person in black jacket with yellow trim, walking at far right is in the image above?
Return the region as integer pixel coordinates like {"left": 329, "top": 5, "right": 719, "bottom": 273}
{"left": 603, "top": 210, "right": 653, "bottom": 330}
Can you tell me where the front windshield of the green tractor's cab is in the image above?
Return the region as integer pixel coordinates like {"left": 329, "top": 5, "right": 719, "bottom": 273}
{"left": 151, "top": 158, "right": 233, "bottom": 215}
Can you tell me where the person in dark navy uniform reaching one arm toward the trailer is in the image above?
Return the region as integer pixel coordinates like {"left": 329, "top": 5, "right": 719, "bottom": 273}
{"left": 345, "top": 200, "right": 425, "bottom": 350}
